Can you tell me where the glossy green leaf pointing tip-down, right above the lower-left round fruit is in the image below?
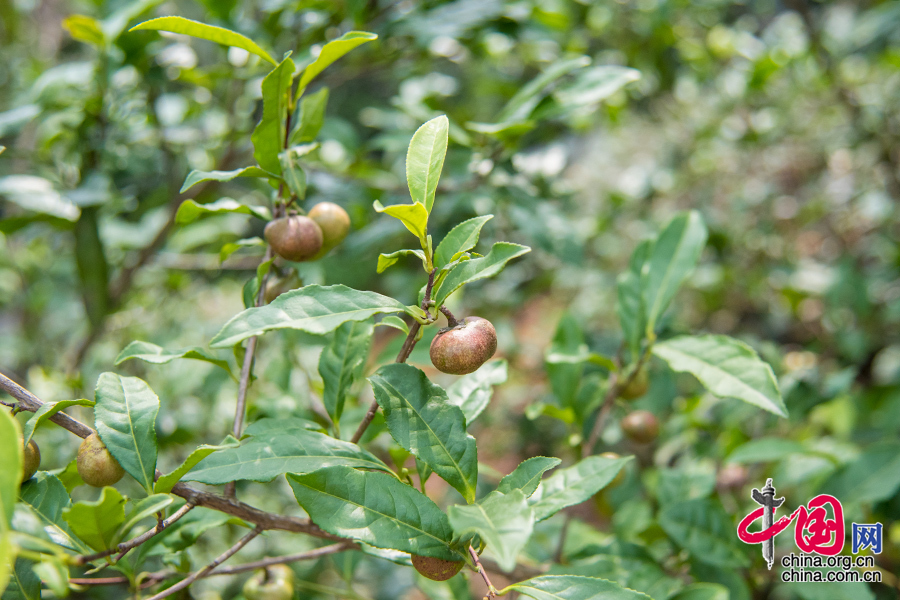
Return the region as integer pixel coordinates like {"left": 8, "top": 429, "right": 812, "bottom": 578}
{"left": 94, "top": 373, "right": 159, "bottom": 494}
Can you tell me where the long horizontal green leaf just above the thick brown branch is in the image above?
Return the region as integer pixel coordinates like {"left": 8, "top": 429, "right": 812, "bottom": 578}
{"left": 182, "top": 429, "right": 390, "bottom": 485}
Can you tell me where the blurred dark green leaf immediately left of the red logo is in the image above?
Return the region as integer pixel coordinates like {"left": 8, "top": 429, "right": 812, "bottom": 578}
{"left": 659, "top": 498, "right": 749, "bottom": 568}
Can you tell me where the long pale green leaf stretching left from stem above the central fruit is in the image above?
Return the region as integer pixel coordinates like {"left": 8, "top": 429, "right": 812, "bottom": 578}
{"left": 209, "top": 285, "right": 406, "bottom": 348}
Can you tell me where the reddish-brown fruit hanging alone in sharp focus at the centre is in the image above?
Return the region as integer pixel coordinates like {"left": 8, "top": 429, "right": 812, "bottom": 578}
{"left": 430, "top": 317, "right": 497, "bottom": 375}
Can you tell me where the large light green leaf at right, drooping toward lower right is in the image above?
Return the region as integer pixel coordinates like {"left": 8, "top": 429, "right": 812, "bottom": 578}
{"left": 653, "top": 335, "right": 788, "bottom": 418}
